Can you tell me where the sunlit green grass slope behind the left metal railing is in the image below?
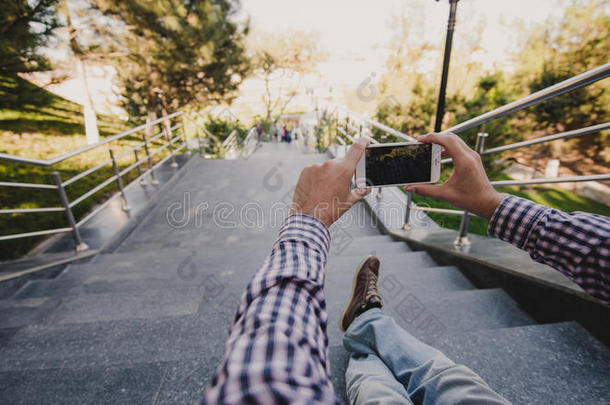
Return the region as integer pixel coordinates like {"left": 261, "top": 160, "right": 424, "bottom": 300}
{"left": 0, "top": 76, "right": 167, "bottom": 260}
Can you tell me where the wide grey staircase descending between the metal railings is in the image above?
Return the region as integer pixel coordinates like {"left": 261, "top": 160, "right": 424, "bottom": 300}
{"left": 0, "top": 144, "right": 610, "bottom": 404}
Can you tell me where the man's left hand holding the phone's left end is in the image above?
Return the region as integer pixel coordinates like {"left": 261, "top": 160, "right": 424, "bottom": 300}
{"left": 290, "top": 138, "right": 370, "bottom": 227}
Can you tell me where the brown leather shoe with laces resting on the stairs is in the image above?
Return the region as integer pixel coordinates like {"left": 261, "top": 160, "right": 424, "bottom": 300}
{"left": 339, "top": 256, "right": 383, "bottom": 332}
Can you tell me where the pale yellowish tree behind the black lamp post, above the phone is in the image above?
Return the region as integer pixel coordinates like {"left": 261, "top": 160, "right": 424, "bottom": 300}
{"left": 374, "top": 8, "right": 481, "bottom": 140}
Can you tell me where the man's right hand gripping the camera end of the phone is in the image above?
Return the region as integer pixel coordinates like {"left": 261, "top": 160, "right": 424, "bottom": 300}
{"left": 405, "top": 133, "right": 505, "bottom": 219}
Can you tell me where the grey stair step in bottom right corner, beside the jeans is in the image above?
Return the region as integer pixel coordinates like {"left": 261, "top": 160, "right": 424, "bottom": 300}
{"left": 438, "top": 322, "right": 610, "bottom": 404}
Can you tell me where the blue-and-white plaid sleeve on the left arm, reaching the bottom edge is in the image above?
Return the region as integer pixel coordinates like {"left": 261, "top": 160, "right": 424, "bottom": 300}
{"left": 201, "top": 214, "right": 337, "bottom": 404}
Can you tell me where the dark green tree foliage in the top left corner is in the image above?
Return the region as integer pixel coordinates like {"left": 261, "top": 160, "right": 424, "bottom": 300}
{"left": 0, "top": 0, "right": 59, "bottom": 75}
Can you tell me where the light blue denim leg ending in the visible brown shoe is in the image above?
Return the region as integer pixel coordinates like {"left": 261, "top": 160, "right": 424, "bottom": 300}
{"left": 343, "top": 308, "right": 509, "bottom": 404}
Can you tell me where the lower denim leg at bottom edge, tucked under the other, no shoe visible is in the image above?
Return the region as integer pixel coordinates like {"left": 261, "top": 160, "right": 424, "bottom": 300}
{"left": 345, "top": 353, "right": 413, "bottom": 405}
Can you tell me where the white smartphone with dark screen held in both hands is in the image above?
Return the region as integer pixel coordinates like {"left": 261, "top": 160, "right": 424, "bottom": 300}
{"left": 356, "top": 142, "right": 441, "bottom": 188}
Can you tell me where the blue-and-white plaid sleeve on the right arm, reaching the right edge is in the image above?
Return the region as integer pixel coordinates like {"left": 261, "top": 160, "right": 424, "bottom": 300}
{"left": 488, "top": 196, "right": 610, "bottom": 305}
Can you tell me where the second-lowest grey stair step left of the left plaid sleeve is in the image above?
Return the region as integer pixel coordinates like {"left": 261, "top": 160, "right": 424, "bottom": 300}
{"left": 0, "top": 307, "right": 229, "bottom": 372}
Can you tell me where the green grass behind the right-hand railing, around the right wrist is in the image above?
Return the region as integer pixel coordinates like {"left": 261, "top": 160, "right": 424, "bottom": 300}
{"left": 401, "top": 163, "right": 610, "bottom": 236}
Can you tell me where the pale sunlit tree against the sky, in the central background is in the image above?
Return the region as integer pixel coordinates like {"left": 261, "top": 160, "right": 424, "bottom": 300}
{"left": 252, "top": 31, "right": 326, "bottom": 122}
